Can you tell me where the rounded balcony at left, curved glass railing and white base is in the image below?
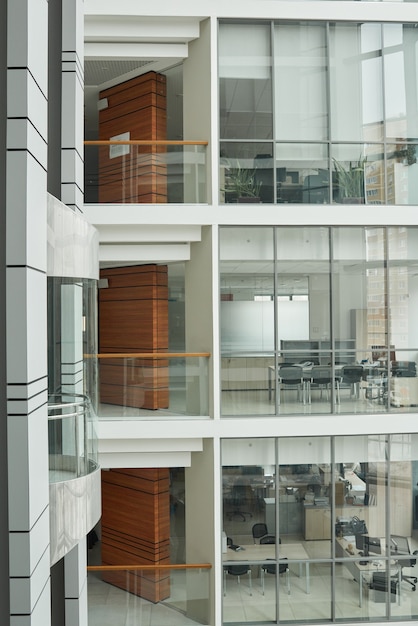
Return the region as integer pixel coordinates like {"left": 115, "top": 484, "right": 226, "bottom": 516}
{"left": 48, "top": 393, "right": 101, "bottom": 565}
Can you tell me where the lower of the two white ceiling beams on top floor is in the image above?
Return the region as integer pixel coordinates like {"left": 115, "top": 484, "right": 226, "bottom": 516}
{"left": 84, "top": 42, "right": 188, "bottom": 61}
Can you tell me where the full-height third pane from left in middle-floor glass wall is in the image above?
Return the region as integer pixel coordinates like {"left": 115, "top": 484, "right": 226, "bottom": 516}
{"left": 332, "top": 228, "right": 389, "bottom": 412}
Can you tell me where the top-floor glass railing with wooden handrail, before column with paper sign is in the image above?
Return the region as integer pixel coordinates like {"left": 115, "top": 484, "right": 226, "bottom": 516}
{"left": 84, "top": 140, "right": 207, "bottom": 204}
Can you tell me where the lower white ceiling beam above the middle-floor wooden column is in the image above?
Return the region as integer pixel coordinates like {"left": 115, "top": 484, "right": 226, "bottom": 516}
{"left": 99, "top": 243, "right": 190, "bottom": 263}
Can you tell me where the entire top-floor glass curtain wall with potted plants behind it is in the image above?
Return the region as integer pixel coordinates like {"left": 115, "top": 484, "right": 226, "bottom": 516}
{"left": 219, "top": 22, "right": 418, "bottom": 205}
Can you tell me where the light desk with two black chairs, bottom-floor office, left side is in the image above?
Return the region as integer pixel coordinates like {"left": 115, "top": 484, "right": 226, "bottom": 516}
{"left": 222, "top": 543, "right": 310, "bottom": 593}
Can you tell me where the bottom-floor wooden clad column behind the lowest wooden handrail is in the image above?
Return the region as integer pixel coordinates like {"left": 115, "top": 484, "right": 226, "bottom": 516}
{"left": 102, "top": 468, "right": 170, "bottom": 602}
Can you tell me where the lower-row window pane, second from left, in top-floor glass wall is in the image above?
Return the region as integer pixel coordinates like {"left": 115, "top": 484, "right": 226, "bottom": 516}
{"left": 276, "top": 143, "right": 329, "bottom": 204}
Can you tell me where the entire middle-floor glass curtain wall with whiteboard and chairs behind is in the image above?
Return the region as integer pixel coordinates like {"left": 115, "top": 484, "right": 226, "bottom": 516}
{"left": 220, "top": 227, "right": 418, "bottom": 416}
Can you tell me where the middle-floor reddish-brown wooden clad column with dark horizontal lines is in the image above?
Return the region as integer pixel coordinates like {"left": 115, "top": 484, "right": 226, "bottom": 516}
{"left": 99, "top": 264, "right": 169, "bottom": 409}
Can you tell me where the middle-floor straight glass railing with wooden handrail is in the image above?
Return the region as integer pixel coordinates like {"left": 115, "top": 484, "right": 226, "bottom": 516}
{"left": 97, "top": 352, "right": 210, "bottom": 418}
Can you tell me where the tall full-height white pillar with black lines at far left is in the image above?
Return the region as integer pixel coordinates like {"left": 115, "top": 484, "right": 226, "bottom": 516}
{"left": 6, "top": 0, "right": 51, "bottom": 626}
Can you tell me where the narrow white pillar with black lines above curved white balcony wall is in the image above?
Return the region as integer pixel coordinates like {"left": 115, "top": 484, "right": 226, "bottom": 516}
{"left": 61, "top": 0, "right": 84, "bottom": 211}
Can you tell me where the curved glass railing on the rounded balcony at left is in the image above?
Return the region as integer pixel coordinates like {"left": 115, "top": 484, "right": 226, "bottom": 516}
{"left": 48, "top": 393, "right": 98, "bottom": 483}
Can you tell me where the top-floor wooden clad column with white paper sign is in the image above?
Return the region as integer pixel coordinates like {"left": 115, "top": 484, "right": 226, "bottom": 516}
{"left": 99, "top": 72, "right": 167, "bottom": 203}
